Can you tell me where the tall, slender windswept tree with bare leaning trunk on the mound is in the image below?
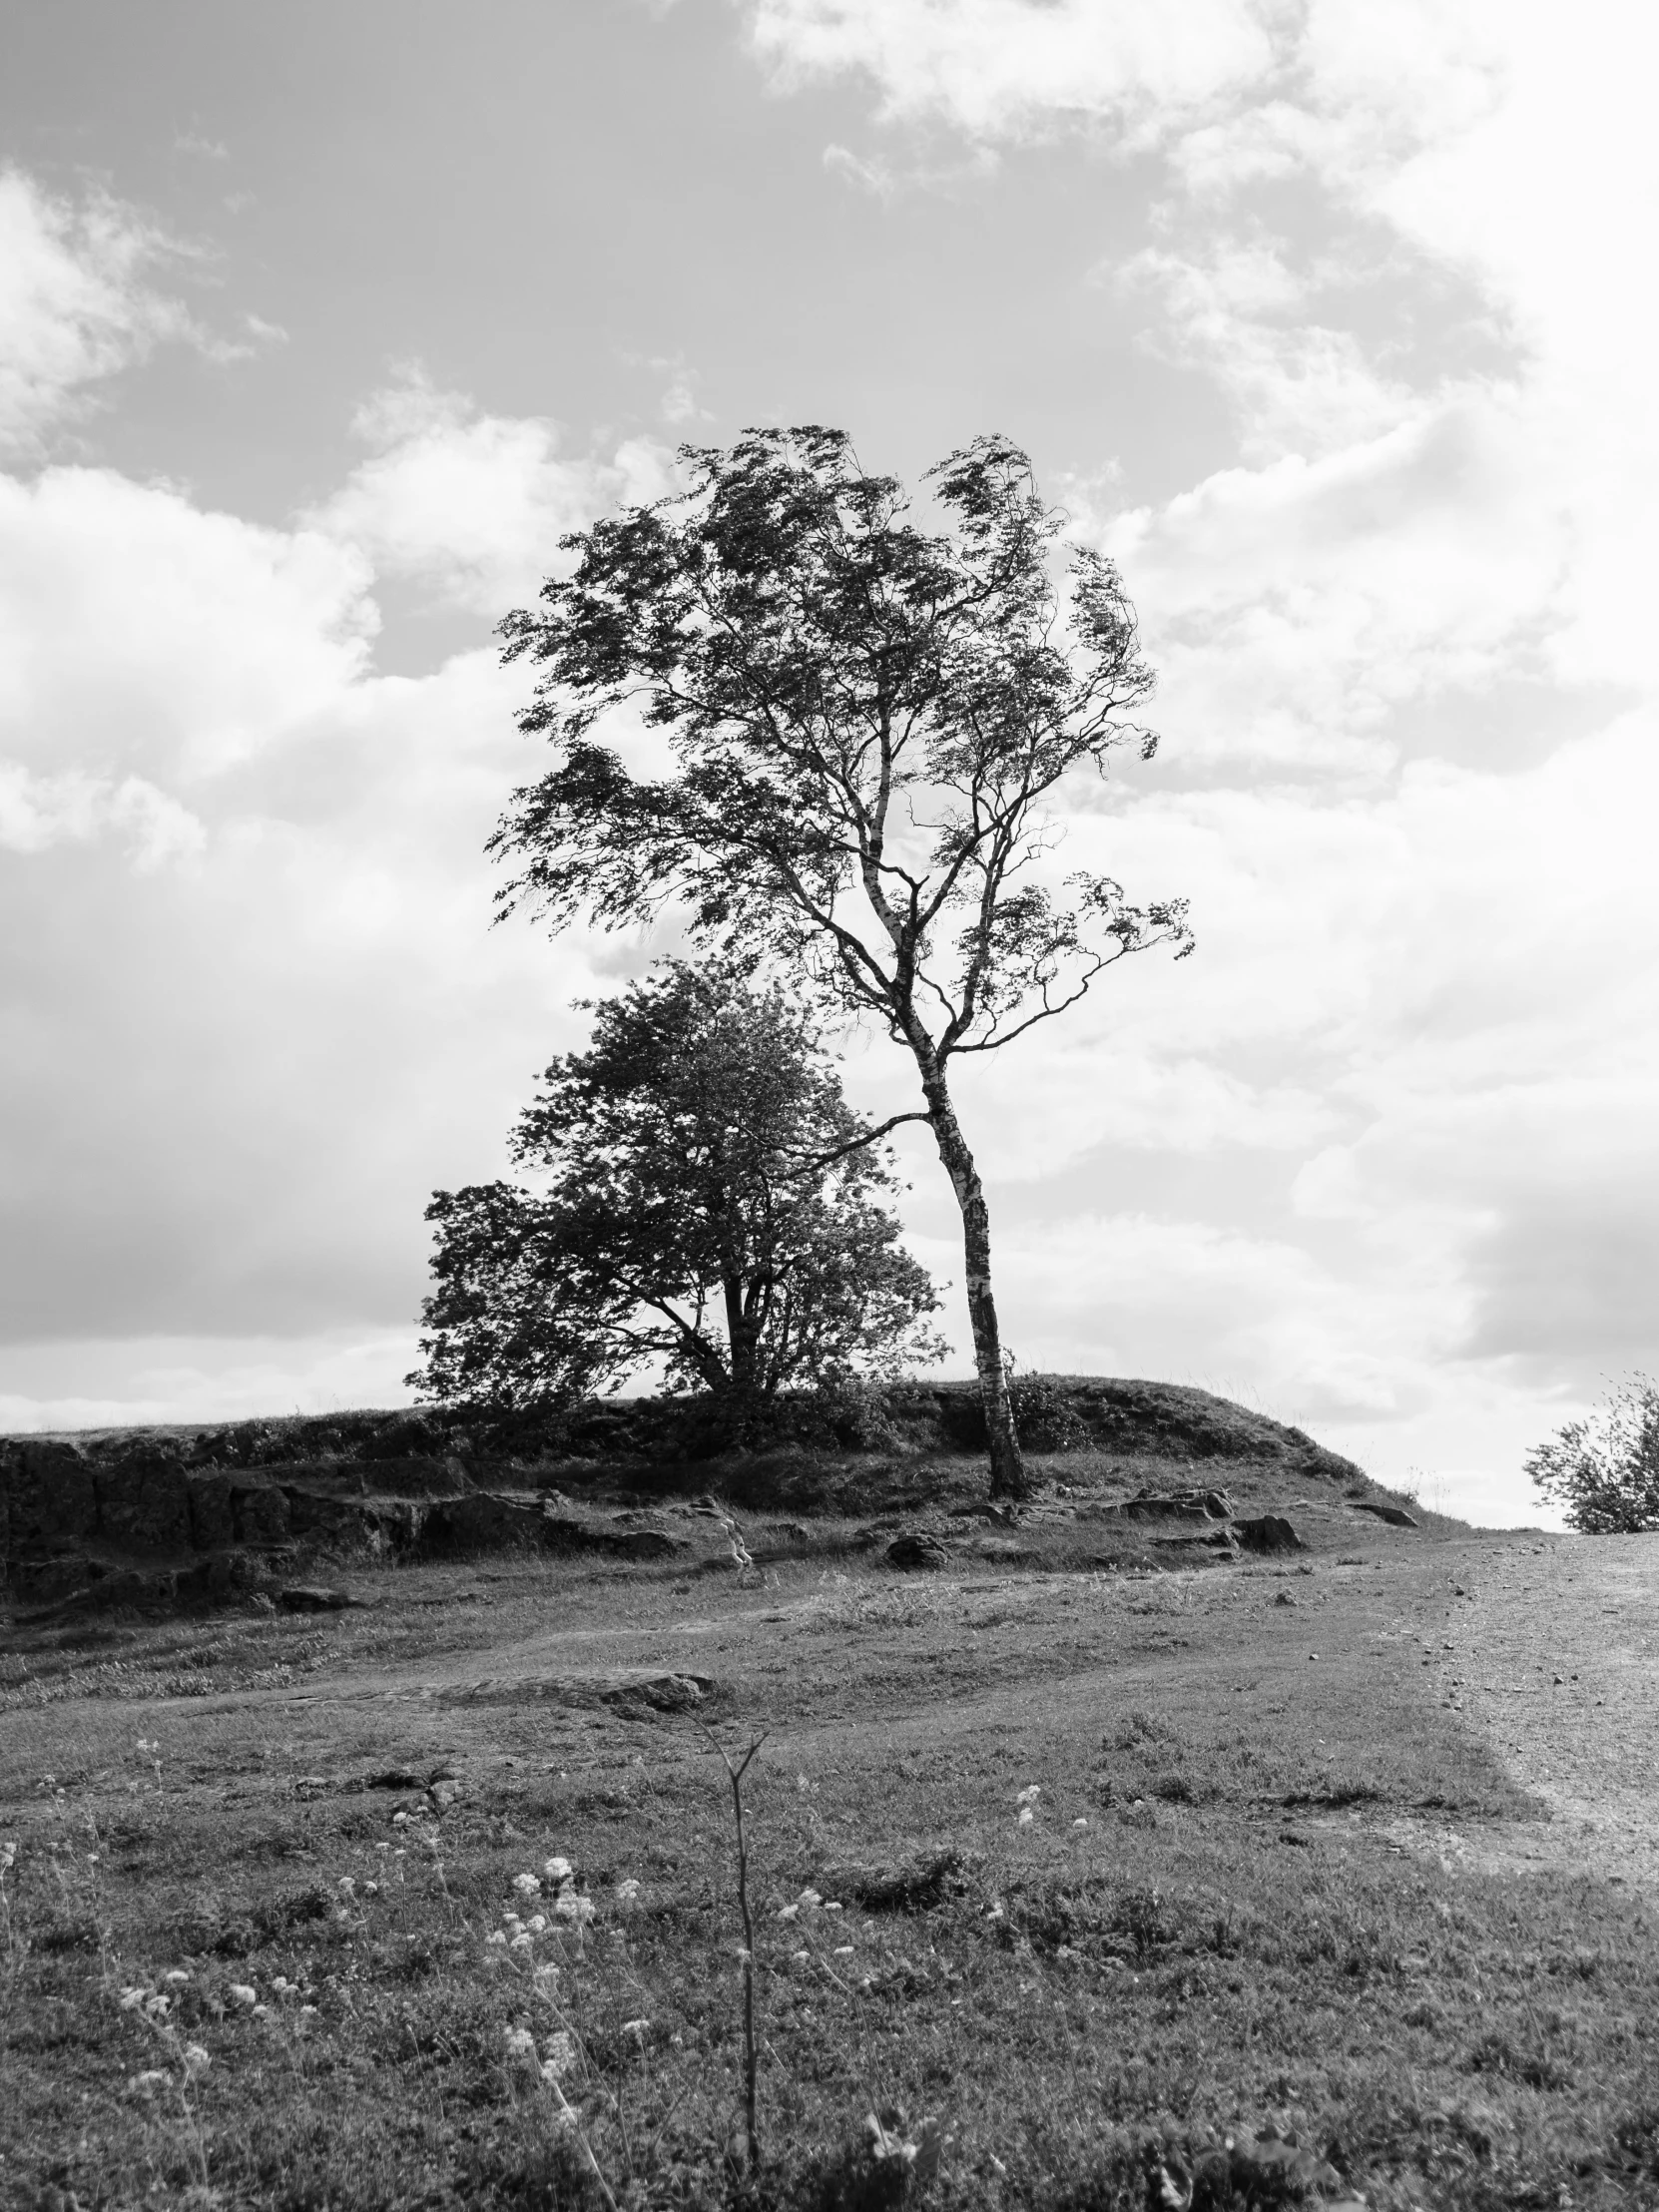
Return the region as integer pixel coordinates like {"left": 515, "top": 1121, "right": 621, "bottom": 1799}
{"left": 491, "top": 429, "right": 1190, "bottom": 1495}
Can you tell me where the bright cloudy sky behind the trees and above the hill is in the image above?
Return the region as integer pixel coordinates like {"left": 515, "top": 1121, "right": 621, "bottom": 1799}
{"left": 0, "top": 0, "right": 1659, "bottom": 1524}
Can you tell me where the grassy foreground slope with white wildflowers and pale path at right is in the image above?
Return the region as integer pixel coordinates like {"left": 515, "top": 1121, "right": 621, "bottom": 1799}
{"left": 0, "top": 1468, "right": 1659, "bottom": 2212}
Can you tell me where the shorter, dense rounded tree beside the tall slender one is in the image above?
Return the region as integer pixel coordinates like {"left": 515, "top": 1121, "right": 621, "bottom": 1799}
{"left": 411, "top": 962, "right": 942, "bottom": 1433}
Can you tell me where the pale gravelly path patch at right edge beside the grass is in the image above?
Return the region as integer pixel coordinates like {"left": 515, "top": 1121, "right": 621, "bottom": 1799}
{"left": 1406, "top": 1537, "right": 1659, "bottom": 1883}
